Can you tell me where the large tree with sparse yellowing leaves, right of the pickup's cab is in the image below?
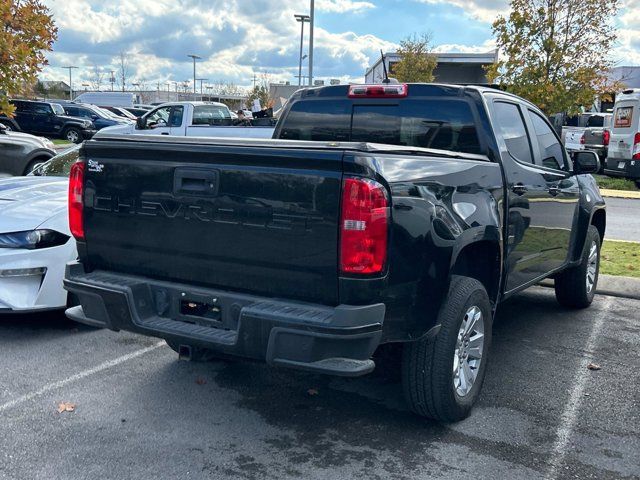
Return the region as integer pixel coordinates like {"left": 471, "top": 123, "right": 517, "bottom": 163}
{"left": 487, "top": 0, "right": 619, "bottom": 115}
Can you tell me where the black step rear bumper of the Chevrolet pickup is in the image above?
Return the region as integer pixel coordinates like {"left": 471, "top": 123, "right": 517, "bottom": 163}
{"left": 64, "top": 262, "right": 385, "bottom": 376}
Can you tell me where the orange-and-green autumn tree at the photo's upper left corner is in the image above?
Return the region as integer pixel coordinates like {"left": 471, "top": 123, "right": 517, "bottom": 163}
{"left": 0, "top": 0, "right": 57, "bottom": 115}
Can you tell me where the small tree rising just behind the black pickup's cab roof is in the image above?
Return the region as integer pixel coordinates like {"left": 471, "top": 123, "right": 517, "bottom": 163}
{"left": 393, "top": 33, "right": 438, "bottom": 83}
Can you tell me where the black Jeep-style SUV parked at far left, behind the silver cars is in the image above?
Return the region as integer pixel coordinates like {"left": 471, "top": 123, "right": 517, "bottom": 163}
{"left": 0, "top": 100, "right": 96, "bottom": 143}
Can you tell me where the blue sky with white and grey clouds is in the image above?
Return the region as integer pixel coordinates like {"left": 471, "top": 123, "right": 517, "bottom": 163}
{"left": 41, "top": 0, "right": 640, "bottom": 89}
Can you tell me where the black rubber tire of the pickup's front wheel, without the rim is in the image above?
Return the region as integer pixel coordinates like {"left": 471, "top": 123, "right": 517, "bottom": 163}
{"left": 555, "top": 225, "right": 601, "bottom": 308}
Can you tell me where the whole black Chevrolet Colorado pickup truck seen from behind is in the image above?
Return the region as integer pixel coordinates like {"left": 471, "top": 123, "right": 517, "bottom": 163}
{"left": 65, "top": 84, "right": 606, "bottom": 421}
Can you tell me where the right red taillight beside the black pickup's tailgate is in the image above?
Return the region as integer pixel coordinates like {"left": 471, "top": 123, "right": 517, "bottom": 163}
{"left": 340, "top": 178, "right": 389, "bottom": 275}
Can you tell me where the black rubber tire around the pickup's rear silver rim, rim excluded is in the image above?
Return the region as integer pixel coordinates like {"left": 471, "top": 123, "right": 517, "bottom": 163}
{"left": 402, "top": 276, "right": 492, "bottom": 423}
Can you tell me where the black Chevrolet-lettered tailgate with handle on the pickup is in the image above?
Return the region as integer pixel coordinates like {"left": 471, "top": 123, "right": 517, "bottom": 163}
{"left": 85, "top": 139, "right": 342, "bottom": 304}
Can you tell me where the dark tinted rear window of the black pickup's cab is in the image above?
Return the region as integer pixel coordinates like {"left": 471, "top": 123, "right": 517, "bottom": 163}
{"left": 279, "top": 99, "right": 482, "bottom": 153}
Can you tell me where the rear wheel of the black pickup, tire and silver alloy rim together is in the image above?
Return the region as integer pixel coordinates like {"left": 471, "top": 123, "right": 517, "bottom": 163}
{"left": 402, "top": 276, "right": 492, "bottom": 422}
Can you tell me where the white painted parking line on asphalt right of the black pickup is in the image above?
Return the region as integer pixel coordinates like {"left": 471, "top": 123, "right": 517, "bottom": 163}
{"left": 545, "top": 297, "right": 613, "bottom": 480}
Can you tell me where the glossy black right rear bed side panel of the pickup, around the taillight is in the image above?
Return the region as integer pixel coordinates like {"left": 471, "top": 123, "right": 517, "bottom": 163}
{"left": 340, "top": 154, "right": 504, "bottom": 341}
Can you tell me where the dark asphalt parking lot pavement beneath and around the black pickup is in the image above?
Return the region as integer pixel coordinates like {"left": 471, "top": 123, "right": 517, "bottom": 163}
{"left": 0, "top": 288, "right": 640, "bottom": 480}
